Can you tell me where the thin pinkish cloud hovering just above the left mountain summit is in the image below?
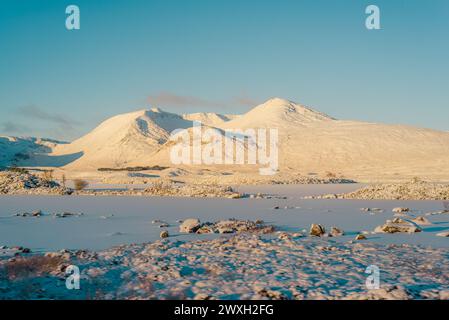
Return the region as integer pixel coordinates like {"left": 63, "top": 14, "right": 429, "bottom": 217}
{"left": 147, "top": 92, "right": 227, "bottom": 108}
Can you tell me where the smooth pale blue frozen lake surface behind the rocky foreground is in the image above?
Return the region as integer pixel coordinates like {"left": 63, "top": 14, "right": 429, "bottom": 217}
{"left": 0, "top": 185, "right": 449, "bottom": 251}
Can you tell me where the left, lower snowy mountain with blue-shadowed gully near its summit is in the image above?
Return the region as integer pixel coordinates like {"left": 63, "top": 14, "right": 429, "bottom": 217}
{"left": 50, "top": 108, "right": 242, "bottom": 169}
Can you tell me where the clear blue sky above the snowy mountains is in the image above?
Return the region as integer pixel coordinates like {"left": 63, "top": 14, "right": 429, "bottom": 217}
{"left": 0, "top": 0, "right": 449, "bottom": 140}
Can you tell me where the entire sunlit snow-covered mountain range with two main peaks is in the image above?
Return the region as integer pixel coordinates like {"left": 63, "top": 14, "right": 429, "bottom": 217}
{"left": 0, "top": 98, "right": 449, "bottom": 180}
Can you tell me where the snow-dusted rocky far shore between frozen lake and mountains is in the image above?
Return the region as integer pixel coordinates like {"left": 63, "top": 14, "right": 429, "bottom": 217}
{"left": 5, "top": 171, "right": 449, "bottom": 201}
